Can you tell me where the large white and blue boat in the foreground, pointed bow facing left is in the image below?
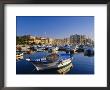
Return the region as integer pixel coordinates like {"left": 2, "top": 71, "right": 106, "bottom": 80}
{"left": 26, "top": 54, "right": 72, "bottom": 70}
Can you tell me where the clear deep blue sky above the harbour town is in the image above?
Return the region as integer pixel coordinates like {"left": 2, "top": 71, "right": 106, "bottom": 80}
{"left": 16, "top": 16, "right": 94, "bottom": 39}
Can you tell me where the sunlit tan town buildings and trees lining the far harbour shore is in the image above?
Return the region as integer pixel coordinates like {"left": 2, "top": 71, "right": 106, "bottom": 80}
{"left": 16, "top": 34, "right": 94, "bottom": 45}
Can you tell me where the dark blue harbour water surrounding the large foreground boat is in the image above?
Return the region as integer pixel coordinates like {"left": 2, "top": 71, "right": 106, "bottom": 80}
{"left": 16, "top": 51, "right": 94, "bottom": 74}
